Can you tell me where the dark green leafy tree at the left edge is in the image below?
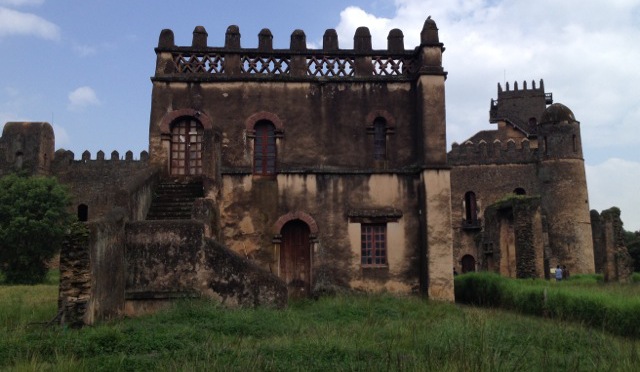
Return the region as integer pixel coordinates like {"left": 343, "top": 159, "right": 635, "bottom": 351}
{"left": 0, "top": 174, "right": 71, "bottom": 284}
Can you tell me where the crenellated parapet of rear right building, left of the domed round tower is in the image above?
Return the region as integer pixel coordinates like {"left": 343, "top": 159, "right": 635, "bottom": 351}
{"left": 447, "top": 138, "right": 538, "bottom": 165}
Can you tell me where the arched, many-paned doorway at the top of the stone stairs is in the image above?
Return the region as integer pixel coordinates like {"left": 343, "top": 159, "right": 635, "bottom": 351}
{"left": 171, "top": 116, "right": 204, "bottom": 176}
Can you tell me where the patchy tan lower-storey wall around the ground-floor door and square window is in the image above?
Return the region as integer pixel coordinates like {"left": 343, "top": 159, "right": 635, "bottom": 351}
{"left": 220, "top": 173, "right": 422, "bottom": 292}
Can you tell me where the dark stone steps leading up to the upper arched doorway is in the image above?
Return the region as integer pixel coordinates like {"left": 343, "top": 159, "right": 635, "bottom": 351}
{"left": 147, "top": 180, "right": 204, "bottom": 220}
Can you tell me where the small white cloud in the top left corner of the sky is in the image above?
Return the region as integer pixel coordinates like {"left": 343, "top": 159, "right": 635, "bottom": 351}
{"left": 0, "top": 7, "right": 60, "bottom": 40}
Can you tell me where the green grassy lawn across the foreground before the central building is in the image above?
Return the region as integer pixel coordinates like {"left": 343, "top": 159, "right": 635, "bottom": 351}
{"left": 0, "top": 274, "right": 640, "bottom": 371}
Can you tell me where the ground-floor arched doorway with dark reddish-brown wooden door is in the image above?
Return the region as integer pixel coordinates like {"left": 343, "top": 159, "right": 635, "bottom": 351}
{"left": 280, "top": 219, "right": 311, "bottom": 297}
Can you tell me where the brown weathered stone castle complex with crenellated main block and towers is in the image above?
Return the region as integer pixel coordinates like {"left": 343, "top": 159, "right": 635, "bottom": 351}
{"left": 0, "top": 18, "right": 620, "bottom": 324}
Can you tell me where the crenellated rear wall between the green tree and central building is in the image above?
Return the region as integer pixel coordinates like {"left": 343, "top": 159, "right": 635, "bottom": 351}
{"left": 52, "top": 150, "right": 158, "bottom": 221}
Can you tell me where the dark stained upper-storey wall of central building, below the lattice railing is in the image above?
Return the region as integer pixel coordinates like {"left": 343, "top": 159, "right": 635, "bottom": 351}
{"left": 150, "top": 82, "right": 418, "bottom": 176}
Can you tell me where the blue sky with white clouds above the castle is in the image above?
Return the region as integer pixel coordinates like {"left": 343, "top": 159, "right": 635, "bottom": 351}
{"left": 0, "top": 0, "right": 640, "bottom": 231}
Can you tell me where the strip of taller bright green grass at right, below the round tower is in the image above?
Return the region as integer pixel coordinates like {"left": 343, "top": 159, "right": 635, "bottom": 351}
{"left": 456, "top": 273, "right": 640, "bottom": 338}
